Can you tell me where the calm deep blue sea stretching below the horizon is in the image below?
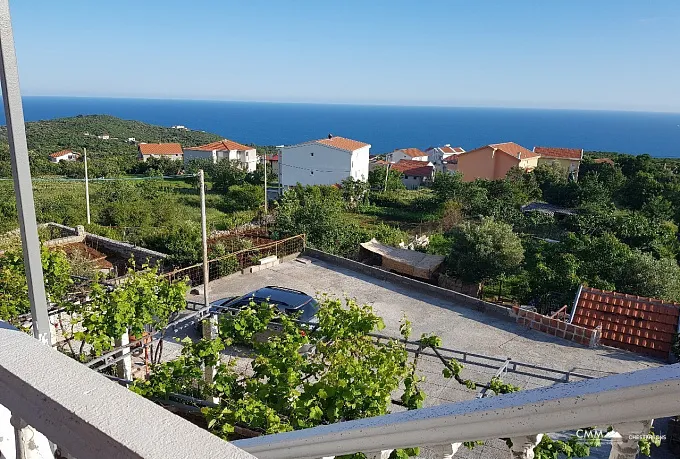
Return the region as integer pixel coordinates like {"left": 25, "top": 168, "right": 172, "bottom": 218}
{"left": 5, "top": 97, "right": 680, "bottom": 157}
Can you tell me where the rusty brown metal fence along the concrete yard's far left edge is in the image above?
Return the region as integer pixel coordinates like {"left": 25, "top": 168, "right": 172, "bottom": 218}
{"left": 165, "top": 234, "right": 306, "bottom": 286}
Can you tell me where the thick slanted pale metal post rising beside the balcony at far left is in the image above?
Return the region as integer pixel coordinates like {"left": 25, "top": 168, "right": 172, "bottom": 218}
{"left": 0, "top": 0, "right": 51, "bottom": 345}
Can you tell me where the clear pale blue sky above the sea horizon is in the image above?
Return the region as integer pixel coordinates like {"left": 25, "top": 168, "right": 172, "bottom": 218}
{"left": 10, "top": 0, "right": 680, "bottom": 112}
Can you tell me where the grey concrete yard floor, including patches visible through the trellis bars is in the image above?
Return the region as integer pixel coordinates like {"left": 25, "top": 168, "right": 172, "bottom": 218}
{"left": 174, "top": 257, "right": 671, "bottom": 459}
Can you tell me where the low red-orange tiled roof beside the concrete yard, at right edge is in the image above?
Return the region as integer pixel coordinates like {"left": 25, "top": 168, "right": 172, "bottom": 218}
{"left": 572, "top": 287, "right": 680, "bottom": 359}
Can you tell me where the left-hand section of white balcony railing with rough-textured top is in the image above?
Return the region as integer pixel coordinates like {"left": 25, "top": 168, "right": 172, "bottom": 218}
{"left": 0, "top": 322, "right": 254, "bottom": 459}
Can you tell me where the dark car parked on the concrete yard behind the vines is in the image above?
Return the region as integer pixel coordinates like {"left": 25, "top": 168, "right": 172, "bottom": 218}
{"left": 199, "top": 286, "right": 319, "bottom": 334}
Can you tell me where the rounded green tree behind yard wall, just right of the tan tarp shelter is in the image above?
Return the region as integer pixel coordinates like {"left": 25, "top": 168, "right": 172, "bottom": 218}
{"left": 446, "top": 218, "right": 524, "bottom": 282}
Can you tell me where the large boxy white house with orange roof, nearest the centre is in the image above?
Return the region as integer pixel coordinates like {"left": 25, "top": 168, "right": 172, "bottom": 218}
{"left": 279, "top": 135, "right": 371, "bottom": 187}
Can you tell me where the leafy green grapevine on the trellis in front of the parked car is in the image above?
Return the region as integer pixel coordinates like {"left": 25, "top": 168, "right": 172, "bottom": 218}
{"left": 133, "top": 297, "right": 425, "bottom": 452}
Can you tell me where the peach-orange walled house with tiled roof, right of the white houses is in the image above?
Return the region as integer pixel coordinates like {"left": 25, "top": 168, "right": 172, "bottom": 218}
{"left": 456, "top": 142, "right": 539, "bottom": 182}
